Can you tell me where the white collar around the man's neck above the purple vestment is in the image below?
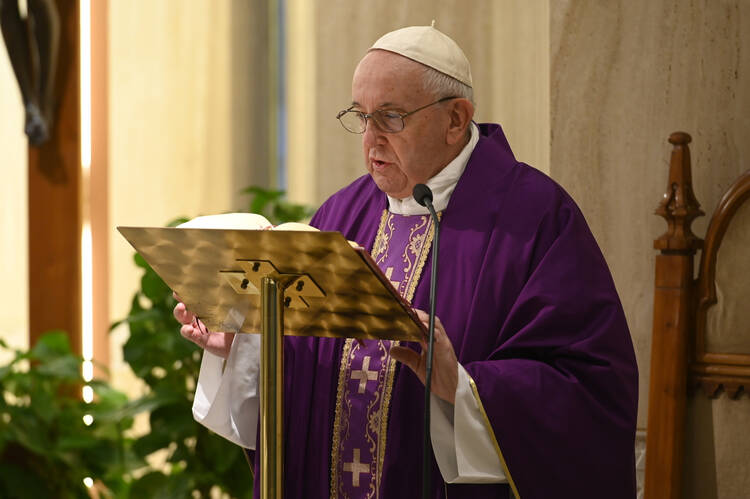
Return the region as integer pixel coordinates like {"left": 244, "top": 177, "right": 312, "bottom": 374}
{"left": 388, "top": 122, "right": 479, "bottom": 215}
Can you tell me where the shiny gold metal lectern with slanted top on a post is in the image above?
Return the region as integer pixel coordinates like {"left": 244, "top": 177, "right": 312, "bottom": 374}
{"left": 118, "top": 227, "right": 426, "bottom": 499}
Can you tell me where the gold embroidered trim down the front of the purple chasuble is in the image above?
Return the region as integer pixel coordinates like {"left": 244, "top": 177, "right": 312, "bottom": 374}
{"left": 331, "top": 209, "right": 442, "bottom": 499}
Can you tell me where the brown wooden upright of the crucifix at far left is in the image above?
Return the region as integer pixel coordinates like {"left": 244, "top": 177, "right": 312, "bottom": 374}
{"left": 28, "top": 1, "right": 81, "bottom": 354}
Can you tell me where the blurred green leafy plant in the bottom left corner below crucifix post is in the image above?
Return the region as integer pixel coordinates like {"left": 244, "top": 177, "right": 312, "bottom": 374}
{"left": 0, "top": 331, "right": 144, "bottom": 498}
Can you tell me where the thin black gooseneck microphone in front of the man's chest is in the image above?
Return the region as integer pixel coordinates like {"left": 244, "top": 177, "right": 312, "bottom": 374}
{"left": 412, "top": 184, "right": 440, "bottom": 499}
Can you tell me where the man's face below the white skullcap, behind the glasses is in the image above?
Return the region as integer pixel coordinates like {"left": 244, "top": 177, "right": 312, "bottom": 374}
{"left": 352, "top": 50, "right": 453, "bottom": 199}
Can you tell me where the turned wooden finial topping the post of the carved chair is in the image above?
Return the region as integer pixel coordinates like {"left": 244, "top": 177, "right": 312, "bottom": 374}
{"left": 654, "top": 132, "right": 704, "bottom": 253}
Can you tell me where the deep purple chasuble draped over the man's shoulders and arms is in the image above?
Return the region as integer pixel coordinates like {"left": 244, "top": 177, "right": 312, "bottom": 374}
{"left": 250, "top": 124, "right": 638, "bottom": 499}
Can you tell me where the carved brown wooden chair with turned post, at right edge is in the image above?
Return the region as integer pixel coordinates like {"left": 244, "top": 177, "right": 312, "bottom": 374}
{"left": 644, "top": 132, "right": 750, "bottom": 499}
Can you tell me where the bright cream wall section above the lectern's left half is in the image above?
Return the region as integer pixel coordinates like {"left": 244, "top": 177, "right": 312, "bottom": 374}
{"left": 108, "top": 0, "right": 268, "bottom": 393}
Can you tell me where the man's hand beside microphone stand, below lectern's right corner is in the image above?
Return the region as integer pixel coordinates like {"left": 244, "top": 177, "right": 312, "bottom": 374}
{"left": 391, "top": 310, "right": 458, "bottom": 404}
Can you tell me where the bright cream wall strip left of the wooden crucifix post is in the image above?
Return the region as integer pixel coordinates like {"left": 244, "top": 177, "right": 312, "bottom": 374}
{"left": 0, "top": 37, "right": 29, "bottom": 364}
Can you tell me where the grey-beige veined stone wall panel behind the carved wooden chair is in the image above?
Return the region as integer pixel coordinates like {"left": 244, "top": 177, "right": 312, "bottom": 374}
{"left": 550, "top": 0, "right": 750, "bottom": 427}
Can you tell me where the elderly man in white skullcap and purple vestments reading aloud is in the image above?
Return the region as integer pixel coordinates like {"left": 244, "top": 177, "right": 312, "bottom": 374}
{"left": 175, "top": 27, "right": 637, "bottom": 499}
